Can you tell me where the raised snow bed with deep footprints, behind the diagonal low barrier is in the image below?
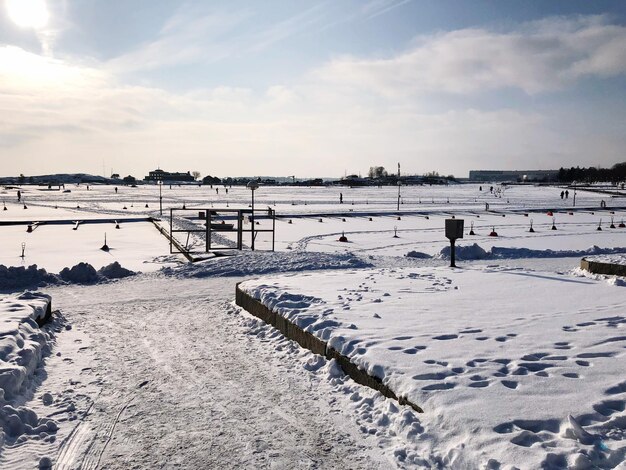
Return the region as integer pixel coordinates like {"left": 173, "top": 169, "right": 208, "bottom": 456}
{"left": 240, "top": 267, "right": 626, "bottom": 468}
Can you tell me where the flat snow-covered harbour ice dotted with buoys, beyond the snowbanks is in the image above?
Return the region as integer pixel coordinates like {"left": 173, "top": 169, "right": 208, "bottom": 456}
{"left": 0, "top": 184, "right": 626, "bottom": 264}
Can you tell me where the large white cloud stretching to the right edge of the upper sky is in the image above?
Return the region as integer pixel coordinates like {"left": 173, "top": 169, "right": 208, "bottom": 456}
{"left": 318, "top": 16, "right": 626, "bottom": 96}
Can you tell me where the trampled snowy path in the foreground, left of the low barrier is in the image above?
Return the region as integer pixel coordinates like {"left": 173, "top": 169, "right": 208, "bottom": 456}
{"left": 52, "top": 277, "right": 391, "bottom": 469}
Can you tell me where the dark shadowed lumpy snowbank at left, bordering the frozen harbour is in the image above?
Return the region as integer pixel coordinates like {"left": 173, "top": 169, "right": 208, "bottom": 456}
{"left": 0, "top": 261, "right": 136, "bottom": 292}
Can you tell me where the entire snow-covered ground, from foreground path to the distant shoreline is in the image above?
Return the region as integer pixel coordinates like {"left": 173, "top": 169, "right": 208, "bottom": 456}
{"left": 0, "top": 185, "right": 626, "bottom": 468}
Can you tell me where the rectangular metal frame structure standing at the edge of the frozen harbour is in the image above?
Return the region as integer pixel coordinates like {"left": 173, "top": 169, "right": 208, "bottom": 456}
{"left": 169, "top": 207, "right": 276, "bottom": 254}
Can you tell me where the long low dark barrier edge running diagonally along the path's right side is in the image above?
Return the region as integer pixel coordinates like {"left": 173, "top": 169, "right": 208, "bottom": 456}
{"left": 235, "top": 284, "right": 424, "bottom": 413}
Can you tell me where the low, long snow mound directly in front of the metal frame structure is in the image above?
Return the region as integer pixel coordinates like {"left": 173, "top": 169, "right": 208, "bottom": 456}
{"left": 162, "top": 252, "right": 372, "bottom": 277}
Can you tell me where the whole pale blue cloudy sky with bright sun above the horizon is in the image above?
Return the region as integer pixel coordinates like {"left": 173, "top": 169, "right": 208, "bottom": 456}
{"left": 0, "top": 0, "right": 626, "bottom": 178}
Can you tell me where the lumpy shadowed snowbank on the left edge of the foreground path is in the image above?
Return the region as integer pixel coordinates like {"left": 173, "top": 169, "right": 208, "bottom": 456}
{"left": 0, "top": 292, "right": 57, "bottom": 446}
